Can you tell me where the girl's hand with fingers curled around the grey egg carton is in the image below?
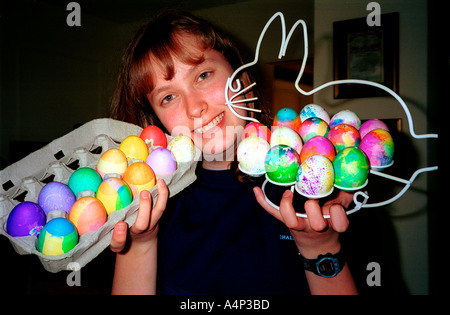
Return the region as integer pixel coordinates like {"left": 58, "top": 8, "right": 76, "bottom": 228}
{"left": 109, "top": 179, "right": 169, "bottom": 253}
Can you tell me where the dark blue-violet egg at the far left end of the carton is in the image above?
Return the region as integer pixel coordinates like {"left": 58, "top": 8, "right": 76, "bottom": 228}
{"left": 6, "top": 201, "right": 45, "bottom": 237}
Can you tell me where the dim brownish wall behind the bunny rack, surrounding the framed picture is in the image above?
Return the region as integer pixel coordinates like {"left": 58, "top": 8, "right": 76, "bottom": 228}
{"left": 314, "top": 0, "right": 436, "bottom": 294}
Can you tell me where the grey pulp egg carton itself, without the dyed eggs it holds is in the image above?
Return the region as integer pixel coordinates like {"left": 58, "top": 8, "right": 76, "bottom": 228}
{"left": 0, "top": 118, "right": 200, "bottom": 273}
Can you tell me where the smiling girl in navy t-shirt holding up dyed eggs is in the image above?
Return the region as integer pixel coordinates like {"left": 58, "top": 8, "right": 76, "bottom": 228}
{"left": 110, "top": 11, "right": 356, "bottom": 294}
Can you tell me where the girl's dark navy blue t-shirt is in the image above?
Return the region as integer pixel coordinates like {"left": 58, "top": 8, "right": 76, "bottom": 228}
{"left": 157, "top": 164, "right": 309, "bottom": 294}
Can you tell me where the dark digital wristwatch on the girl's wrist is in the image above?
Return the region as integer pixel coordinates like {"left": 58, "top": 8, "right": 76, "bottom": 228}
{"left": 299, "top": 251, "right": 345, "bottom": 278}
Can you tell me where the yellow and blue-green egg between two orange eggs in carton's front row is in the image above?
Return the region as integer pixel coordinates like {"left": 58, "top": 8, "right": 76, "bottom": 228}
{"left": 95, "top": 177, "right": 133, "bottom": 215}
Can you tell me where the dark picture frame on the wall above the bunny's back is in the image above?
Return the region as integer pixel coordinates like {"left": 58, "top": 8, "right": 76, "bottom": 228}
{"left": 333, "top": 12, "right": 399, "bottom": 99}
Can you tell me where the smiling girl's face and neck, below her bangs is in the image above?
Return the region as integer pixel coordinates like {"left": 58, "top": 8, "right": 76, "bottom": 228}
{"left": 147, "top": 39, "right": 246, "bottom": 169}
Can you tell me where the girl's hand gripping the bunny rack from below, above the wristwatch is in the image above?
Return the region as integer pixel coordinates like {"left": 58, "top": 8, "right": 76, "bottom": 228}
{"left": 253, "top": 187, "right": 353, "bottom": 259}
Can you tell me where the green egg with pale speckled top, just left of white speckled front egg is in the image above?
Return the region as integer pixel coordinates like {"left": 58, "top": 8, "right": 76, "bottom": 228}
{"left": 265, "top": 144, "right": 300, "bottom": 186}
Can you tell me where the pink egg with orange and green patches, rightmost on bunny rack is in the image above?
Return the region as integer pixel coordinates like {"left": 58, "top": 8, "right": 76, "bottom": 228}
{"left": 359, "top": 129, "right": 394, "bottom": 170}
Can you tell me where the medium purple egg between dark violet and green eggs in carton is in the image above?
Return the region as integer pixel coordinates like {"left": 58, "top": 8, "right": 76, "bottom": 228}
{"left": 38, "top": 182, "right": 77, "bottom": 215}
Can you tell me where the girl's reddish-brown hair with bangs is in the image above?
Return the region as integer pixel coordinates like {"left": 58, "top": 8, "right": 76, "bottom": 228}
{"left": 111, "top": 10, "right": 272, "bottom": 132}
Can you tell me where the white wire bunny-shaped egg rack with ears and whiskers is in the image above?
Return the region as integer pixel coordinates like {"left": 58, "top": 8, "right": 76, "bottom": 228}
{"left": 225, "top": 12, "right": 438, "bottom": 218}
